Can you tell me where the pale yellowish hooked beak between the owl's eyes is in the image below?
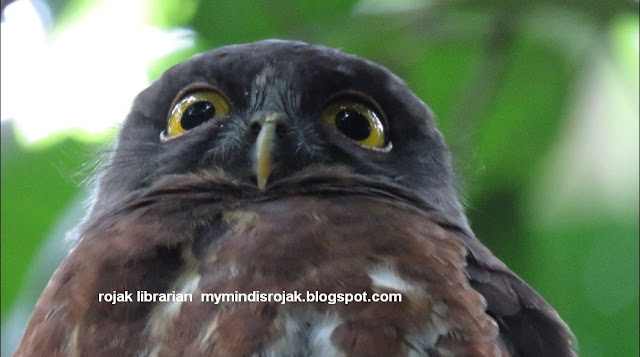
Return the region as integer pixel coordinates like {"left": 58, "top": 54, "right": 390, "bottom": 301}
{"left": 255, "top": 113, "right": 284, "bottom": 190}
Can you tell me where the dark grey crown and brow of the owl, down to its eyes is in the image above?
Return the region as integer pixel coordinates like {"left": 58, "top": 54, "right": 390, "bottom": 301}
{"left": 133, "top": 40, "right": 435, "bottom": 136}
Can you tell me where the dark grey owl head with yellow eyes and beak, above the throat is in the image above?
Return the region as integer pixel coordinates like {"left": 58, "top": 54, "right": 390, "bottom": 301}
{"left": 94, "top": 40, "right": 466, "bottom": 226}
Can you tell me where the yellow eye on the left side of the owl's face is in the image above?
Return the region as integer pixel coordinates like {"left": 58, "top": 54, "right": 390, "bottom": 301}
{"left": 167, "top": 90, "right": 229, "bottom": 137}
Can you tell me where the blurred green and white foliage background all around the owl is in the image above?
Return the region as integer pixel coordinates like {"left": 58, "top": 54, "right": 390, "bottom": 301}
{"left": 0, "top": 0, "right": 639, "bottom": 356}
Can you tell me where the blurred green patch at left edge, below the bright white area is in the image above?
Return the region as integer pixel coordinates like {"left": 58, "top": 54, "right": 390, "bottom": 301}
{"left": 0, "top": 122, "right": 96, "bottom": 317}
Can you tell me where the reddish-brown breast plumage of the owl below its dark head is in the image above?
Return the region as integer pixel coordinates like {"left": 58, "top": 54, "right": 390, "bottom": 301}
{"left": 16, "top": 171, "right": 516, "bottom": 356}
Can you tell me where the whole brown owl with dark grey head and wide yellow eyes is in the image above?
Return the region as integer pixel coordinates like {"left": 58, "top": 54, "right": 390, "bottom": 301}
{"left": 16, "top": 40, "right": 576, "bottom": 357}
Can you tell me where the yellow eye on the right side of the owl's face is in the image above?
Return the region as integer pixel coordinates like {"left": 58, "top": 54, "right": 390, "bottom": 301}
{"left": 323, "top": 100, "right": 387, "bottom": 148}
